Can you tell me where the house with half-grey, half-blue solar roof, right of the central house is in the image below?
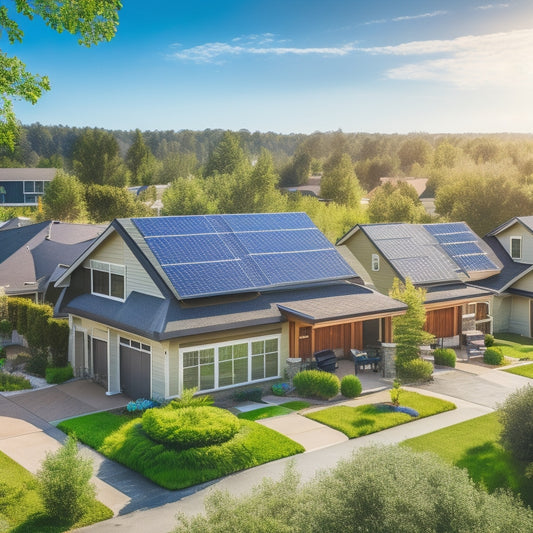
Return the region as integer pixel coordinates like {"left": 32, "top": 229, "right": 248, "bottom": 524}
{"left": 337, "top": 222, "right": 502, "bottom": 346}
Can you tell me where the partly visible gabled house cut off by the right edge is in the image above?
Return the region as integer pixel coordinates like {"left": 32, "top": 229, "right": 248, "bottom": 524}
{"left": 476, "top": 216, "right": 533, "bottom": 337}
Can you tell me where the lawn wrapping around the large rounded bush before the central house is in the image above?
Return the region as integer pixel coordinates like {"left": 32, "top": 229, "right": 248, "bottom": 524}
{"left": 58, "top": 413, "right": 304, "bottom": 490}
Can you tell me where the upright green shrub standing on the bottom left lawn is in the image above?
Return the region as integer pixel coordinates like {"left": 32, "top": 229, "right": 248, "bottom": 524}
{"left": 37, "top": 437, "right": 95, "bottom": 523}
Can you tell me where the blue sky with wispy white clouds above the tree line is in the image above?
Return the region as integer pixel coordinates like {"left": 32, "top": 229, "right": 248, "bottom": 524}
{"left": 9, "top": 0, "right": 533, "bottom": 133}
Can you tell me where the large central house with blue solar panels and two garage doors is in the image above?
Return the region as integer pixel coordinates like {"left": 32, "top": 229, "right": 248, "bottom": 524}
{"left": 56, "top": 213, "right": 406, "bottom": 398}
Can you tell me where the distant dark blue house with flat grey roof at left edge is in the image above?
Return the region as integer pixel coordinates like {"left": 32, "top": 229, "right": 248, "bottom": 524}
{"left": 0, "top": 168, "right": 57, "bottom": 207}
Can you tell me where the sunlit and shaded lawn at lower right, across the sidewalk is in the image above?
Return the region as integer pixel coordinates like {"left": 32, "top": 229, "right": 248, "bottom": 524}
{"left": 401, "top": 412, "right": 533, "bottom": 506}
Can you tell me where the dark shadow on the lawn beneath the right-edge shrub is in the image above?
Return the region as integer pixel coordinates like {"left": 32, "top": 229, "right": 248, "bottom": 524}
{"left": 455, "top": 442, "right": 533, "bottom": 507}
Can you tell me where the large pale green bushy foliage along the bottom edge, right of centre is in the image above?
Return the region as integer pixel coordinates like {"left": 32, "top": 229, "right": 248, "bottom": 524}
{"left": 174, "top": 446, "right": 533, "bottom": 533}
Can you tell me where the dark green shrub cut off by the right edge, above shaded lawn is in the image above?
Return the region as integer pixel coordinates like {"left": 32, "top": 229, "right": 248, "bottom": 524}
{"left": 498, "top": 385, "right": 533, "bottom": 462}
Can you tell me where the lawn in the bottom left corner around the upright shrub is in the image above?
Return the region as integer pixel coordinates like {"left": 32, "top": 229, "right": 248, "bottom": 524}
{"left": 0, "top": 446, "right": 113, "bottom": 533}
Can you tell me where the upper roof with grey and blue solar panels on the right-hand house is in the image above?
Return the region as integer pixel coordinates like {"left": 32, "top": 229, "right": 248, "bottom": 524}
{"left": 337, "top": 222, "right": 501, "bottom": 285}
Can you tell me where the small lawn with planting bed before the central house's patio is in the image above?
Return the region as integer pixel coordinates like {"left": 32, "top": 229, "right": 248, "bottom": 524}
{"left": 305, "top": 391, "right": 455, "bottom": 439}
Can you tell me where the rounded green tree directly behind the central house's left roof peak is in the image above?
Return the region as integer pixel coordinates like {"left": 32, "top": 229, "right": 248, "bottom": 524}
{"left": 85, "top": 185, "right": 152, "bottom": 223}
